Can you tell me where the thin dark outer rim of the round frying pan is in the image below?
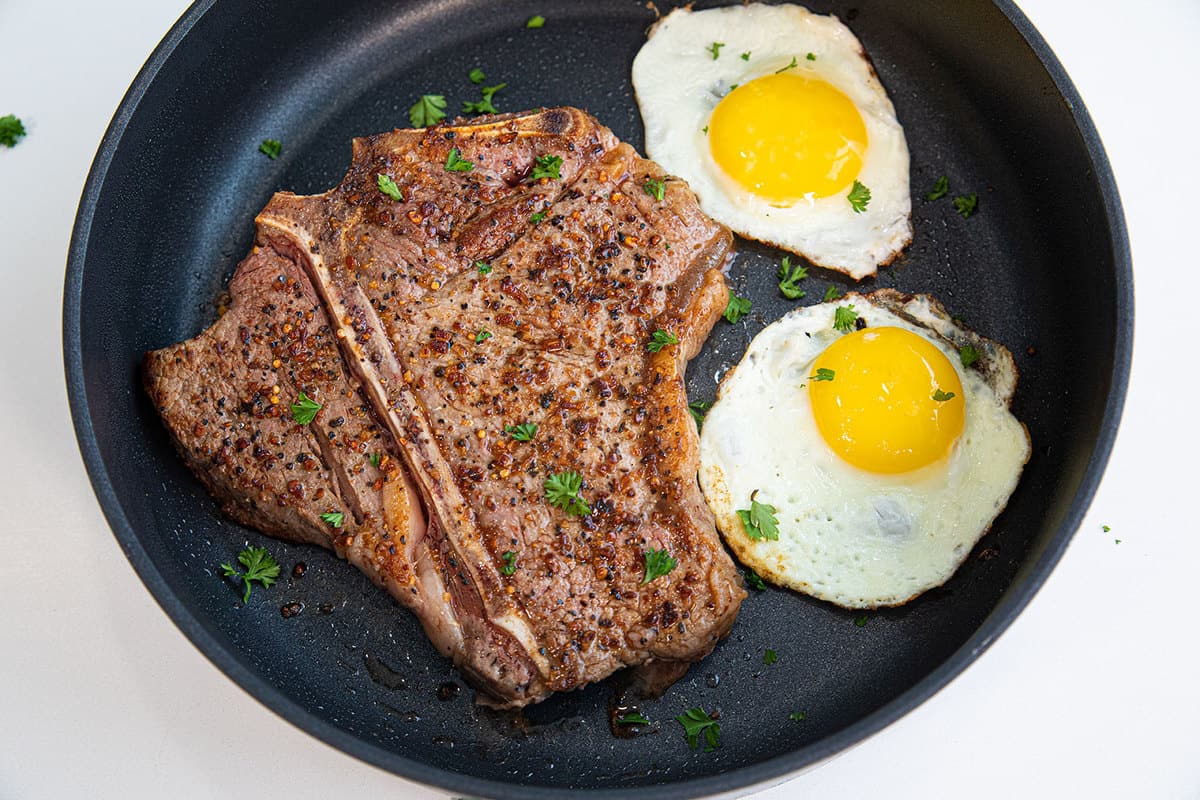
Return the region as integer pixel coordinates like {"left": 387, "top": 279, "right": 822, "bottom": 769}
{"left": 62, "top": 0, "right": 1134, "bottom": 800}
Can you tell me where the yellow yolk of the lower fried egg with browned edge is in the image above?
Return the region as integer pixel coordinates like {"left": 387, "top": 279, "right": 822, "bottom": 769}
{"left": 806, "top": 327, "right": 964, "bottom": 474}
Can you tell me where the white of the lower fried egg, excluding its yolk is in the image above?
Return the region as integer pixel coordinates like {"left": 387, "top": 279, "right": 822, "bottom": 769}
{"left": 700, "top": 290, "right": 1030, "bottom": 608}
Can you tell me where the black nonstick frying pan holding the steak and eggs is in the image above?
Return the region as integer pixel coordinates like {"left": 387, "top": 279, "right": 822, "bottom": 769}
{"left": 64, "top": 0, "right": 1133, "bottom": 798}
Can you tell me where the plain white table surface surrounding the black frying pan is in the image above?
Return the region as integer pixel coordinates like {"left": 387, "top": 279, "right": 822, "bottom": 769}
{"left": 0, "top": 0, "right": 1200, "bottom": 800}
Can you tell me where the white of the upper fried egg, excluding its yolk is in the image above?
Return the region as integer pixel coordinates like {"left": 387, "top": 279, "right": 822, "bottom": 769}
{"left": 632, "top": 4, "right": 912, "bottom": 278}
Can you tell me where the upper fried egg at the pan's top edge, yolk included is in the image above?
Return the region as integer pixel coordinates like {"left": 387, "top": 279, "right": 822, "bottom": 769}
{"left": 632, "top": 4, "right": 912, "bottom": 278}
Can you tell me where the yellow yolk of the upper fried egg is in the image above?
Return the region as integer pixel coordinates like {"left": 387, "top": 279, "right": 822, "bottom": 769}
{"left": 708, "top": 72, "right": 866, "bottom": 205}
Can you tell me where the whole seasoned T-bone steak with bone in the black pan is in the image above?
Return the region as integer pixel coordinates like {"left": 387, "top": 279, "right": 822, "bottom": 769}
{"left": 144, "top": 108, "right": 745, "bottom": 708}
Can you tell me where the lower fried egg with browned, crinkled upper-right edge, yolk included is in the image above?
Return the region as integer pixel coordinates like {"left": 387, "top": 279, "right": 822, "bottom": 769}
{"left": 700, "top": 289, "right": 1030, "bottom": 608}
